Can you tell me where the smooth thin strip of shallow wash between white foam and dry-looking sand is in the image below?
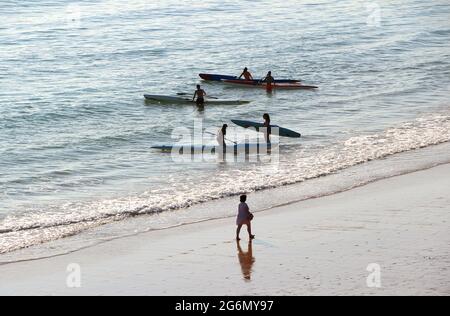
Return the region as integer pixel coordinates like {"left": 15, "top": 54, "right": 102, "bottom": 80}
{"left": 0, "top": 142, "right": 450, "bottom": 266}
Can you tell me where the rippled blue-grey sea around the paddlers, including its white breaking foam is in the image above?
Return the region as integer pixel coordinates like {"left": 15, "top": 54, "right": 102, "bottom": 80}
{"left": 0, "top": 0, "right": 450, "bottom": 253}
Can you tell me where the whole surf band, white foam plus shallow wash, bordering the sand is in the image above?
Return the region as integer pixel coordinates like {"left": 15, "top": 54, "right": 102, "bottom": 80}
{"left": 0, "top": 109, "right": 450, "bottom": 261}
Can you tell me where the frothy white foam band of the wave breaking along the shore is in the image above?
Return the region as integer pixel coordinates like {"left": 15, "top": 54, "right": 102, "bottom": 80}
{"left": 0, "top": 113, "right": 450, "bottom": 253}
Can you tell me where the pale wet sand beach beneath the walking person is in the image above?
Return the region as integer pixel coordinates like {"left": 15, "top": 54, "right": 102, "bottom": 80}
{"left": 0, "top": 164, "right": 450, "bottom": 296}
